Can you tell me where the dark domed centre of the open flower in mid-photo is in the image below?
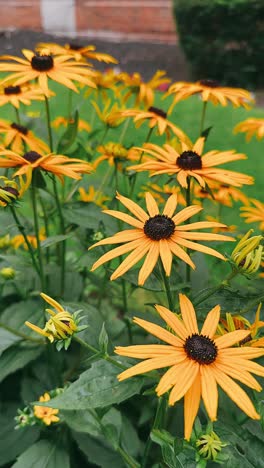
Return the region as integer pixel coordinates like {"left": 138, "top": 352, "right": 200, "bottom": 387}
{"left": 144, "top": 215, "right": 176, "bottom": 240}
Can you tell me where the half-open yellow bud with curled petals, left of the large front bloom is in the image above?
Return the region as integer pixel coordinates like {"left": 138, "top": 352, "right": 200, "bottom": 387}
{"left": 25, "top": 293, "right": 86, "bottom": 350}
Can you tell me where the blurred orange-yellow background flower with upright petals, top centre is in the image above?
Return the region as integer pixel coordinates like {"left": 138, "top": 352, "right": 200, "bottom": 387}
{"left": 119, "top": 70, "right": 171, "bottom": 107}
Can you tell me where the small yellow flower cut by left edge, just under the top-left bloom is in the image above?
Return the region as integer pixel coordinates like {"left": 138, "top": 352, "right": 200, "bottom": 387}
{"left": 0, "top": 85, "right": 48, "bottom": 109}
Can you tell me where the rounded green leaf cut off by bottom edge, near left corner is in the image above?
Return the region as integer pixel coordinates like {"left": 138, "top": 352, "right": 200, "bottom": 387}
{"left": 12, "top": 440, "right": 70, "bottom": 468}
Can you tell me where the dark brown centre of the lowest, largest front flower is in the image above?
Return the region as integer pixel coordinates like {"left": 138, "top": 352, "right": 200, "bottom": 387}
{"left": 184, "top": 333, "right": 217, "bottom": 364}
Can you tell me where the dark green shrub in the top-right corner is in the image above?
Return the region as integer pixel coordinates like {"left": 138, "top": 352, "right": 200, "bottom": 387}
{"left": 174, "top": 0, "right": 264, "bottom": 89}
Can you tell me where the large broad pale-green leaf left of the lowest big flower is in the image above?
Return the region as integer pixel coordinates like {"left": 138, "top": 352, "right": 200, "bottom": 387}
{"left": 39, "top": 357, "right": 144, "bottom": 410}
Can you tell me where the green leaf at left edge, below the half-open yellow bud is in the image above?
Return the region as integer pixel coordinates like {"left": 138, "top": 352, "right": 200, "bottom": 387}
{"left": 0, "top": 343, "right": 43, "bottom": 382}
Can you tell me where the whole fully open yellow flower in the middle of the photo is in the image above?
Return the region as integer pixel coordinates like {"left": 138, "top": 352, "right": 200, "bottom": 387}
{"left": 90, "top": 192, "right": 233, "bottom": 285}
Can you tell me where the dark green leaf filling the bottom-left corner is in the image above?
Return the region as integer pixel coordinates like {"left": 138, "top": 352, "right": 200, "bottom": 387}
{"left": 0, "top": 402, "right": 39, "bottom": 466}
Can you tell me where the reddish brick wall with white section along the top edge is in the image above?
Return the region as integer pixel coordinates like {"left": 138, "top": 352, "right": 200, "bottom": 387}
{"left": 0, "top": 0, "right": 176, "bottom": 43}
